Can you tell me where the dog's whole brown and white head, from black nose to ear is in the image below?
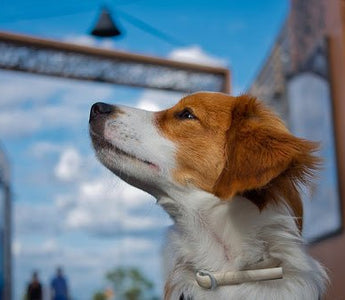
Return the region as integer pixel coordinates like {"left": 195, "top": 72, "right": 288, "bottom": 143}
{"left": 90, "top": 92, "right": 318, "bottom": 227}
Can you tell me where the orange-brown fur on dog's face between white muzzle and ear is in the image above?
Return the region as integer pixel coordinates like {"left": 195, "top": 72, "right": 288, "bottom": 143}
{"left": 156, "top": 93, "right": 230, "bottom": 193}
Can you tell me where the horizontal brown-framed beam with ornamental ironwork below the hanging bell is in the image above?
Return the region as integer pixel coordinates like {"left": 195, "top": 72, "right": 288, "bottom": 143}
{"left": 0, "top": 32, "right": 229, "bottom": 92}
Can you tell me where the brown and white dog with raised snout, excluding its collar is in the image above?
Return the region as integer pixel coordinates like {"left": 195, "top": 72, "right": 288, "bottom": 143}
{"left": 89, "top": 92, "right": 328, "bottom": 300}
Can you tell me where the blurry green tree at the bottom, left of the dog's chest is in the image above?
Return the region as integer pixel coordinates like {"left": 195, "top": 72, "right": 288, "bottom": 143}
{"left": 106, "top": 267, "right": 157, "bottom": 300}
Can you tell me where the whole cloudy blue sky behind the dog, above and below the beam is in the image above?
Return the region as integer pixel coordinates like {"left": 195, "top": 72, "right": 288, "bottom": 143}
{"left": 0, "top": 0, "right": 288, "bottom": 300}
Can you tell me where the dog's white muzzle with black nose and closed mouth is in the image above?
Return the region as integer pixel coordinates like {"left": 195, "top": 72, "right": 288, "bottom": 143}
{"left": 90, "top": 103, "right": 175, "bottom": 196}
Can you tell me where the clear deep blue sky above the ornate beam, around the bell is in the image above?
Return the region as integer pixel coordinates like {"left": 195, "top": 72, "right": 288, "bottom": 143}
{"left": 0, "top": 0, "right": 288, "bottom": 88}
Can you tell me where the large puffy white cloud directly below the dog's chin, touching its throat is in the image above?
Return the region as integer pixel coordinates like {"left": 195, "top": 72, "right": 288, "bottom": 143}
{"left": 57, "top": 174, "right": 170, "bottom": 236}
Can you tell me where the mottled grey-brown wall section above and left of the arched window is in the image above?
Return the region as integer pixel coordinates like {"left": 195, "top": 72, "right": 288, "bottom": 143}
{"left": 249, "top": 0, "right": 327, "bottom": 121}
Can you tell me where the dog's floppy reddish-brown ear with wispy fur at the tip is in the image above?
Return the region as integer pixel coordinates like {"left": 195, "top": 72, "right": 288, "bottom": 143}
{"left": 214, "top": 95, "right": 319, "bottom": 199}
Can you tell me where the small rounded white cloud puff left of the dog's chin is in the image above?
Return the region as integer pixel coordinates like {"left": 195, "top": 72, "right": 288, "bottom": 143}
{"left": 54, "top": 148, "right": 82, "bottom": 181}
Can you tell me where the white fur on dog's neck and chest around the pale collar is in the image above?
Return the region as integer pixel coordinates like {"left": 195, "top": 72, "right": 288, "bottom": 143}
{"left": 160, "top": 192, "right": 327, "bottom": 300}
